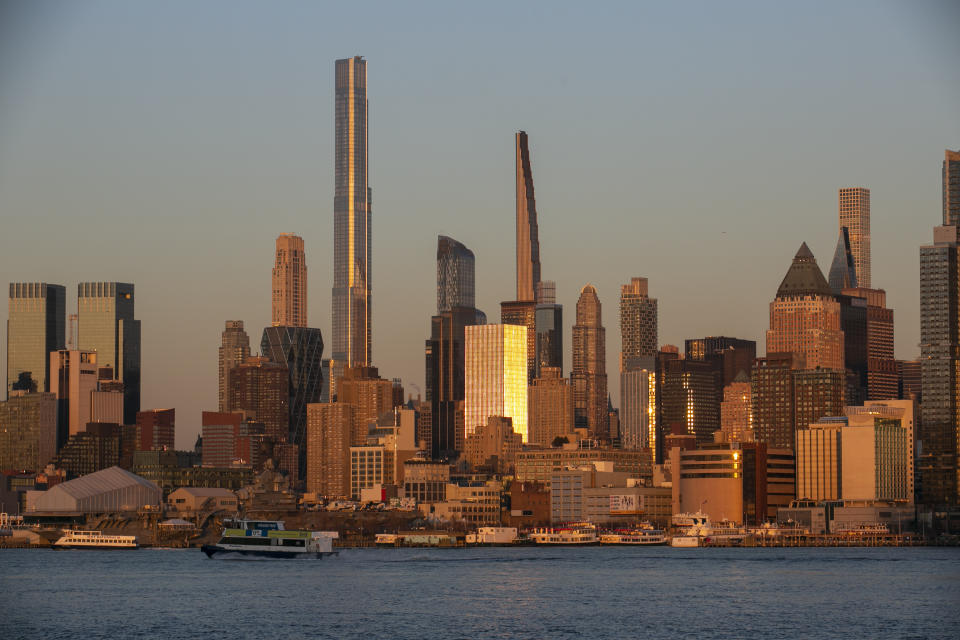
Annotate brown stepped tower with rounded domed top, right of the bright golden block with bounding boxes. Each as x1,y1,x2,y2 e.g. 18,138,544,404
570,284,610,438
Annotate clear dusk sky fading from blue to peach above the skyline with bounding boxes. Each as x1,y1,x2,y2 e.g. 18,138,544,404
0,0,960,448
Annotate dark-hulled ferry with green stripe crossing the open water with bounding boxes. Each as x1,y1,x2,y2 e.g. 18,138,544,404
201,520,338,558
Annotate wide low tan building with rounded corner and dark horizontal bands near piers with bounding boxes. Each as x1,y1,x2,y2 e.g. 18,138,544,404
670,442,796,524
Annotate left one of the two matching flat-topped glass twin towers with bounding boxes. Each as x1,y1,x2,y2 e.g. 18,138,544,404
6,282,67,395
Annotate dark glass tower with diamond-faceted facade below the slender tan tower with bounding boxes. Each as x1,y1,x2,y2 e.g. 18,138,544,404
260,327,323,478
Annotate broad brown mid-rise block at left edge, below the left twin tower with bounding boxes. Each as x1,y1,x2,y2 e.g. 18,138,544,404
0,391,57,471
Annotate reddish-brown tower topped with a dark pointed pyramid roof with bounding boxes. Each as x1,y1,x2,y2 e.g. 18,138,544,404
767,242,844,371
